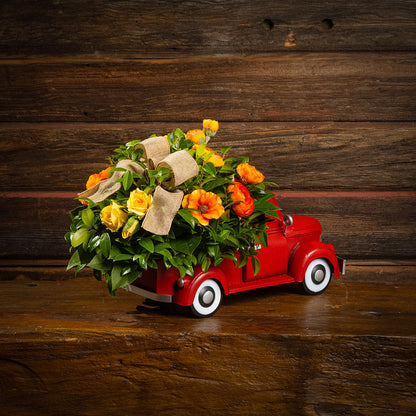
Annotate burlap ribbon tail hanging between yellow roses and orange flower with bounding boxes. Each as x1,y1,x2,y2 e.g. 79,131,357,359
142,186,183,235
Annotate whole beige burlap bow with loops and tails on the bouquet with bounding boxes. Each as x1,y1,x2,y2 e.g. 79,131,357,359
78,136,198,235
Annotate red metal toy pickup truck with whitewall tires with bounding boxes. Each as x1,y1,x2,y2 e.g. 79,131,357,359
126,200,345,318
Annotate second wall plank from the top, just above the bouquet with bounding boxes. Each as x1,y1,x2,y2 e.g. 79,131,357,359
0,52,416,122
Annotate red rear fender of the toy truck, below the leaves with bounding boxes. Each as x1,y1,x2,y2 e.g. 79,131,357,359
173,267,228,306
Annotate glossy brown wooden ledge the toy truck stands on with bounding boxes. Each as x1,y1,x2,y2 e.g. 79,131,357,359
0,279,416,415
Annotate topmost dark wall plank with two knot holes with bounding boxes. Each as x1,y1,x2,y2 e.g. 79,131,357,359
0,0,416,59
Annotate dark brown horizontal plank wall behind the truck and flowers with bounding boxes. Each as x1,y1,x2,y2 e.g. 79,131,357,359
0,0,416,278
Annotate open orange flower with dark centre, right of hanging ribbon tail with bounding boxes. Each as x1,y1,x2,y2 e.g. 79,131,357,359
182,189,224,225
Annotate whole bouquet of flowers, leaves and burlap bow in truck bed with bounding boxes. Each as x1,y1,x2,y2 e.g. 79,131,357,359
65,120,277,295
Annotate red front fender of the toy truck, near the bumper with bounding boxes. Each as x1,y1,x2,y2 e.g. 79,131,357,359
288,241,339,282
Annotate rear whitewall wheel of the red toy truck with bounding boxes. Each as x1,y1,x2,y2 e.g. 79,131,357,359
191,279,222,318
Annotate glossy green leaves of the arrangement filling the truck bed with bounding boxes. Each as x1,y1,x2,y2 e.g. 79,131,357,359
65,125,277,295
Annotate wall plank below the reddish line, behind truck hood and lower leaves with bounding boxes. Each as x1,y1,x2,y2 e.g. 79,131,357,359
0,194,416,259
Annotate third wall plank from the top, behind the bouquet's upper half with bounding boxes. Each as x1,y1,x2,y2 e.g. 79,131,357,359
0,122,416,192
